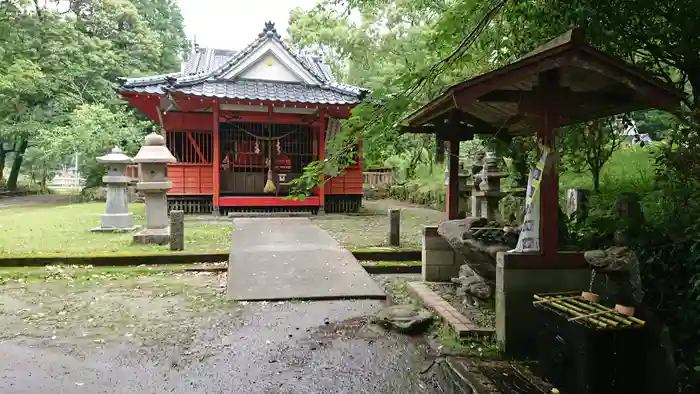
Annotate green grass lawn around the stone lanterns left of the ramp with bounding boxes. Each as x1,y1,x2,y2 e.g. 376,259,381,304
0,203,232,255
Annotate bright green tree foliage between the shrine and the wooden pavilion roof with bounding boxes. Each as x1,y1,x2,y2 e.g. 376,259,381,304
290,0,500,192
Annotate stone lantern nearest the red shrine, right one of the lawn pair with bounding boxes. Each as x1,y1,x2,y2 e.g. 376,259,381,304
134,133,176,245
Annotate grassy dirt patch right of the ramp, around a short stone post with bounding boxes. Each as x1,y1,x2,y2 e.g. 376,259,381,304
312,200,445,248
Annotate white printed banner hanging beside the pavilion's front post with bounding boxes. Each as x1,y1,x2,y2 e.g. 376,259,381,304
510,146,551,253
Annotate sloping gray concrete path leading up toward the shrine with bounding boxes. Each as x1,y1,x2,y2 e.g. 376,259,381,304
227,218,386,301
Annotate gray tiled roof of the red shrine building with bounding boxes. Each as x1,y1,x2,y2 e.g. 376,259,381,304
121,23,366,104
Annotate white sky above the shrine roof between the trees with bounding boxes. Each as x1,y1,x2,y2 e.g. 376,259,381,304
178,0,316,49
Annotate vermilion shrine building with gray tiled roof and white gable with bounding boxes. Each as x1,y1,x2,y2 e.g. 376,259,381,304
120,22,366,213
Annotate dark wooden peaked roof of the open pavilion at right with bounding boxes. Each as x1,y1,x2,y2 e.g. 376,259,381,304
402,28,684,135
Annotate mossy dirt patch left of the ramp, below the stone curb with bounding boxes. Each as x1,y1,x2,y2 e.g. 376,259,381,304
0,267,238,345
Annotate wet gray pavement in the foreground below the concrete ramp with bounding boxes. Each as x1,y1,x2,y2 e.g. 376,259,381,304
0,301,433,394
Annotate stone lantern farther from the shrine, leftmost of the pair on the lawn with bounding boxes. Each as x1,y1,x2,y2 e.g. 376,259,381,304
91,147,137,232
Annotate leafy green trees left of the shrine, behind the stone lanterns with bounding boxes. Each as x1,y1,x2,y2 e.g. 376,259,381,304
0,0,186,189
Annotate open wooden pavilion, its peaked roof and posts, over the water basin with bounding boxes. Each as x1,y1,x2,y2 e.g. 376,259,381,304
404,28,684,264
